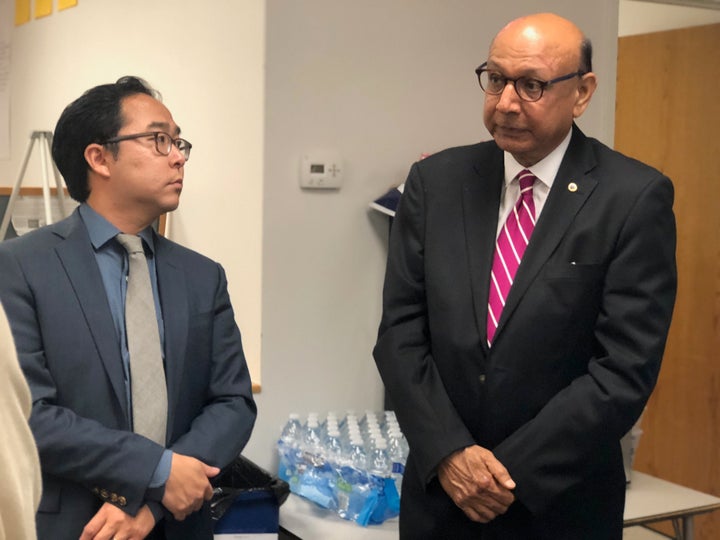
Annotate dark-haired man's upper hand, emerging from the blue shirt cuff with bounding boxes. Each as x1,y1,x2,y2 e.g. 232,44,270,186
162,453,220,521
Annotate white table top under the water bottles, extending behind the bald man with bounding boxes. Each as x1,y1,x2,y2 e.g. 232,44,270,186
280,471,720,540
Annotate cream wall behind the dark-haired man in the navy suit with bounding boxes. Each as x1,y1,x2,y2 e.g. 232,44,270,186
0,0,265,381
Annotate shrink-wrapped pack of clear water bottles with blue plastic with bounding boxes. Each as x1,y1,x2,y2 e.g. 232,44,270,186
277,411,408,527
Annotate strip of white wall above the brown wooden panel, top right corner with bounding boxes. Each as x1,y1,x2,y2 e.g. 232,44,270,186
618,0,720,36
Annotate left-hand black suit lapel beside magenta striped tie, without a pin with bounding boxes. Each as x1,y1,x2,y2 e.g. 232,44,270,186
463,146,504,349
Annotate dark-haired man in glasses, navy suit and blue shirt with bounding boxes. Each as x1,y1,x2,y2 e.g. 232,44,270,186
0,77,256,540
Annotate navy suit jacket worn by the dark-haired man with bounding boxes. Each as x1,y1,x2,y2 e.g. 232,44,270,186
0,212,256,540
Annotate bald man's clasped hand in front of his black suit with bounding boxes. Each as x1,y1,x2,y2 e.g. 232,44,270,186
438,446,515,523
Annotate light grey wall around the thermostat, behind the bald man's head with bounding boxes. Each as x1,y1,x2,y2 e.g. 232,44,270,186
246,0,617,469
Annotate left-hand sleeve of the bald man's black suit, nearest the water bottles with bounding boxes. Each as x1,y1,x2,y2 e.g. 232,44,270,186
373,164,474,482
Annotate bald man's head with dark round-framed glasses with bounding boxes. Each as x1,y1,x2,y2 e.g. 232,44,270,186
479,13,597,167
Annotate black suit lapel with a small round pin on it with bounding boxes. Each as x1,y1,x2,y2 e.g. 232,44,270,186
495,126,597,340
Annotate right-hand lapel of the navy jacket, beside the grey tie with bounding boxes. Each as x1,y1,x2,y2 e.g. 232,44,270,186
155,235,189,437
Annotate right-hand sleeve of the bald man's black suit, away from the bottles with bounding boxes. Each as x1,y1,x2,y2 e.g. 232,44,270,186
493,174,676,513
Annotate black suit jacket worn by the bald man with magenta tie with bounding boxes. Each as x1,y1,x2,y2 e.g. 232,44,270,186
374,127,676,540
